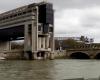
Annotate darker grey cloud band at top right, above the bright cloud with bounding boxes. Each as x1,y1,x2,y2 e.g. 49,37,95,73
48,0,100,8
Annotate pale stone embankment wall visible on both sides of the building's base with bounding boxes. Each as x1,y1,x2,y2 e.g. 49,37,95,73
0,50,67,60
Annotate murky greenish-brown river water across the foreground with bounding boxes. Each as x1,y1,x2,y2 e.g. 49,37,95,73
0,59,100,80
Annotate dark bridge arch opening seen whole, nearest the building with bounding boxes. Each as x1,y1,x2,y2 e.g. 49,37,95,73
69,52,90,59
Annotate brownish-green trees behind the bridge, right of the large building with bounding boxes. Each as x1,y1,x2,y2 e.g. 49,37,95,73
55,36,94,50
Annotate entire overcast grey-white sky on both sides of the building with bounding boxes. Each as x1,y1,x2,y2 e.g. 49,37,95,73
0,0,100,42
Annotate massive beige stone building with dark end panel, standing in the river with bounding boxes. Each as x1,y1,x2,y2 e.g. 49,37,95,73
0,2,54,59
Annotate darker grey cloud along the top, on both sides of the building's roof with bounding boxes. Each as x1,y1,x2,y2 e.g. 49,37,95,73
0,0,100,10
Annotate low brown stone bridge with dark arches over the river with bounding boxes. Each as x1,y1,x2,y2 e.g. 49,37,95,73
66,49,100,59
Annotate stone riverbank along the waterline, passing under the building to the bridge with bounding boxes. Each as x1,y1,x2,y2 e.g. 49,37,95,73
0,50,66,60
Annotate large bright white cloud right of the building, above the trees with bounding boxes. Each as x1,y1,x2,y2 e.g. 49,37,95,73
55,6,100,42
